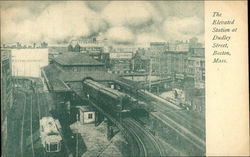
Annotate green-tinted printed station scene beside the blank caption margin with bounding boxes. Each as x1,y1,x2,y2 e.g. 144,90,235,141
0,1,206,157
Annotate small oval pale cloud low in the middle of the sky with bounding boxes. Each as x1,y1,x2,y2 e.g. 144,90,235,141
106,27,135,44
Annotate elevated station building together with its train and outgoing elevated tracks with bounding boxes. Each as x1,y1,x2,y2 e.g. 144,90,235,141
42,54,205,156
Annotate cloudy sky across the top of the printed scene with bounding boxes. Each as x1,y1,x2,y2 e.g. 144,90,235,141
1,1,204,44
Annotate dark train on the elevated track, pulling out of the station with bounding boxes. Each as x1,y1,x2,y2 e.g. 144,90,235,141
83,80,129,113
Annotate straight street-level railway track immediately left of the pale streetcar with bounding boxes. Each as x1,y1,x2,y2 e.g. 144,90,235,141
19,91,45,157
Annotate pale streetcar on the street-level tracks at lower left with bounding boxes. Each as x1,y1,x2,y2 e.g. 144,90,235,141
40,117,62,152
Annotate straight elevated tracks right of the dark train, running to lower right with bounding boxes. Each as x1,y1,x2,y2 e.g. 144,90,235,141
113,81,205,153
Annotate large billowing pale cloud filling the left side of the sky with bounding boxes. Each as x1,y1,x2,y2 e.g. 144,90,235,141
2,1,106,43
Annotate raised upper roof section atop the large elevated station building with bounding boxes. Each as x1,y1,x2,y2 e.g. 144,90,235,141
54,52,104,65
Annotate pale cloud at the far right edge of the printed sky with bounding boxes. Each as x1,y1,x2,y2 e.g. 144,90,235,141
162,16,204,40
